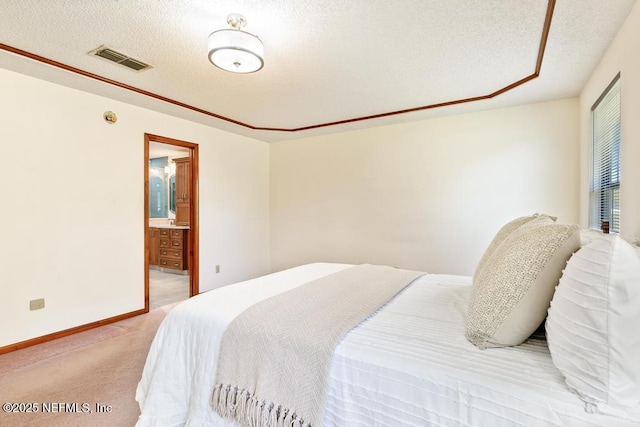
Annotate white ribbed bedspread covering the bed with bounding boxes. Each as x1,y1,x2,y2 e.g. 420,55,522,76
136,264,640,427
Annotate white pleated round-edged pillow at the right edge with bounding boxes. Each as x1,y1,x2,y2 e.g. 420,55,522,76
546,235,640,415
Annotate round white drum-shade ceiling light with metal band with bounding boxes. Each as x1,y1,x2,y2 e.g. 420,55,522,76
209,13,264,73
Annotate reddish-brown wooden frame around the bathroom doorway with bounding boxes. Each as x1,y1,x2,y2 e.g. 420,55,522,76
144,133,200,313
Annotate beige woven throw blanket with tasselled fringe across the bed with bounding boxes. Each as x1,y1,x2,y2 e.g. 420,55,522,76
212,265,424,427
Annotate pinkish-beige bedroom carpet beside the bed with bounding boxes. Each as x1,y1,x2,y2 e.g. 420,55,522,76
0,304,175,427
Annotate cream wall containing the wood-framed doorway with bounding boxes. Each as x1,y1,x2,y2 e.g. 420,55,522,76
0,69,269,347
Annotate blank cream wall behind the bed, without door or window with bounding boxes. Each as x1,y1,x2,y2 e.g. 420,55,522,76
270,98,579,275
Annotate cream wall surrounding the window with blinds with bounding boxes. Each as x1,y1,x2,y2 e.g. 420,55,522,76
580,3,640,240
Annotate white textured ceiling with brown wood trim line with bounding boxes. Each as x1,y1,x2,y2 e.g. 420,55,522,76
0,0,635,141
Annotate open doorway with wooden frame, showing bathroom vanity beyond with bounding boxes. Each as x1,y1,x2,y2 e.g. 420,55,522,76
144,134,199,311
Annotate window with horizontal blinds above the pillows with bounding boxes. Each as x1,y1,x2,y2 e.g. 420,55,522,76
589,73,620,233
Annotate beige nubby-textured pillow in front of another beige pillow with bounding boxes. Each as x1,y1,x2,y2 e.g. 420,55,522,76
465,216,580,348
